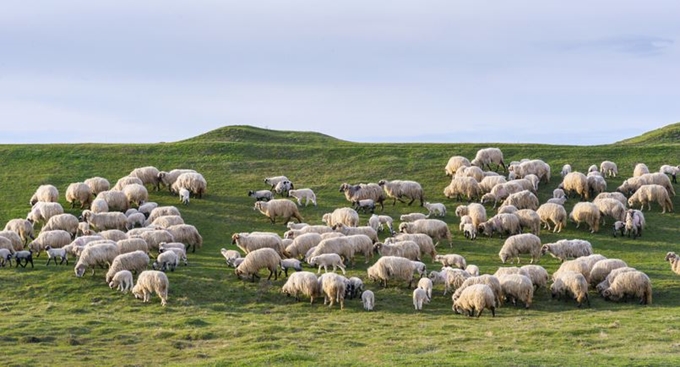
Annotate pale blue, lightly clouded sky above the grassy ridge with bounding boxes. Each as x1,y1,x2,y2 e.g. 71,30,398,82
0,0,680,145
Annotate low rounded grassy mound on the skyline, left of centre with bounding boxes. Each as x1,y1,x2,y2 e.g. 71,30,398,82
182,125,342,145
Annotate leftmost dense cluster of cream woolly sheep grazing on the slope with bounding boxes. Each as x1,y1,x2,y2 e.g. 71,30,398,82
0,166,207,306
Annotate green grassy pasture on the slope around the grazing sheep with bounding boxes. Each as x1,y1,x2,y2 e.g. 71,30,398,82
0,127,680,366
